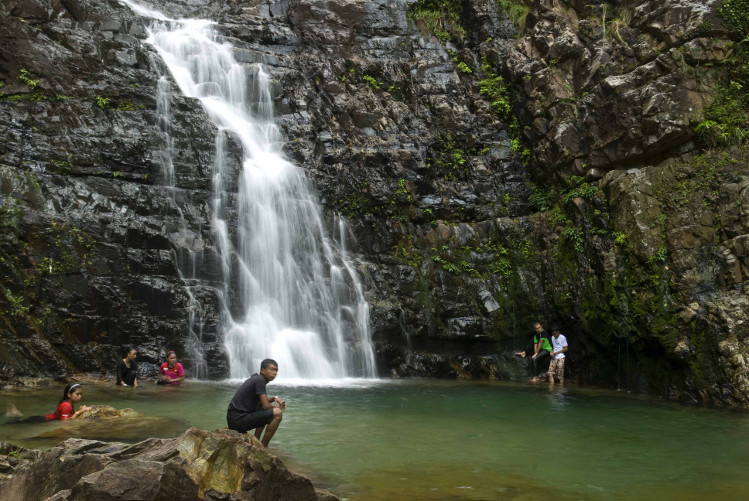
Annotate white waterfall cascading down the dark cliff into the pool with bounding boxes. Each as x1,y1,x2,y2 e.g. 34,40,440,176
121,0,375,379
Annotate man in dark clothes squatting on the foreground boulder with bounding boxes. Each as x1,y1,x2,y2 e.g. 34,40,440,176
226,358,286,447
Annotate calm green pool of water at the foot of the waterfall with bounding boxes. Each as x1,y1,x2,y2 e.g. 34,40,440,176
0,380,749,500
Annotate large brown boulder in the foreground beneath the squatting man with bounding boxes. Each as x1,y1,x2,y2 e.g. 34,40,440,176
0,428,337,501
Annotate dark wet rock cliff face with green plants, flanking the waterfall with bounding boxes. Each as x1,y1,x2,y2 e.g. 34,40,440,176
0,0,749,406
